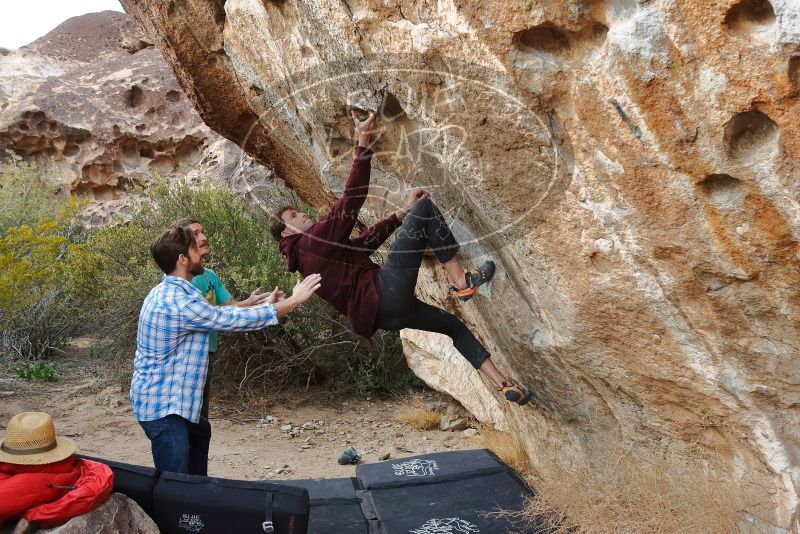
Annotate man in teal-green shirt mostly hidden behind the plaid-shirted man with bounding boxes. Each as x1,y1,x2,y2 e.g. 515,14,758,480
175,219,286,419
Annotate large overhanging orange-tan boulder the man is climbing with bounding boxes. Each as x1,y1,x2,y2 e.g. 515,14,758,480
122,0,800,531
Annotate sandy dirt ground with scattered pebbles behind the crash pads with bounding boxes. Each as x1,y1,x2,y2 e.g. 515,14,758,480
0,355,479,480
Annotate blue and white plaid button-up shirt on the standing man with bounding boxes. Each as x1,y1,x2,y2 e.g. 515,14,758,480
131,276,278,423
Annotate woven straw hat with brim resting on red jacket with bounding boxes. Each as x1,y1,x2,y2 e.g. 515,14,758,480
0,412,78,465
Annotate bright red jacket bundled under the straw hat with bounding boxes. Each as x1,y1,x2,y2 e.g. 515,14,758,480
0,456,114,528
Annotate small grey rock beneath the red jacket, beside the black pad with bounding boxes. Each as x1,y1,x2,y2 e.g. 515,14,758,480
38,493,159,534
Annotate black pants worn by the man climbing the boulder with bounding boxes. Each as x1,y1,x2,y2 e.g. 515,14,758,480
376,199,489,369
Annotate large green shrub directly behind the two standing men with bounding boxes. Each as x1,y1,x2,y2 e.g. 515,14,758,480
83,181,415,398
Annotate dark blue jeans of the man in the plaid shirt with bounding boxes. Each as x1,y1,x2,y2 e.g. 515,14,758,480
139,414,211,476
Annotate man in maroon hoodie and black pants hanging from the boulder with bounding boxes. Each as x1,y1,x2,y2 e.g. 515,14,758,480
270,111,531,405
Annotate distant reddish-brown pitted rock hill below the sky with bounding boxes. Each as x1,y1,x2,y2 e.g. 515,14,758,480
0,11,296,222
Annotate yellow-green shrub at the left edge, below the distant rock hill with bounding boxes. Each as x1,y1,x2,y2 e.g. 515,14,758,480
0,164,94,361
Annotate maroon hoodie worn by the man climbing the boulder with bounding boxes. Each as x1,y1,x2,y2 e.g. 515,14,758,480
280,147,400,337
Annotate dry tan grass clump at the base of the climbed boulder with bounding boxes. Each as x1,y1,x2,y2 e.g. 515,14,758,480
525,439,756,534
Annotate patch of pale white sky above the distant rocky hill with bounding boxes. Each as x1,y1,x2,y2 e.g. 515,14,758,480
0,0,123,48
